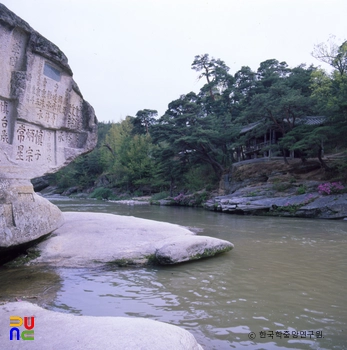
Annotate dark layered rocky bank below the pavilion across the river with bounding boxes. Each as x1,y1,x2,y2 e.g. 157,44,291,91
212,157,347,219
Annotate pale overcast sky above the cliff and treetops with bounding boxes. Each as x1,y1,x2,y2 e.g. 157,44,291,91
0,0,347,122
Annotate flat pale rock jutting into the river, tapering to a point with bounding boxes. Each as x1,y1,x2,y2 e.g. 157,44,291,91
25,212,233,267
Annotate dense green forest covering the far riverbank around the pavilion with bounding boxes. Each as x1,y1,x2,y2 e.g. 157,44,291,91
54,38,347,198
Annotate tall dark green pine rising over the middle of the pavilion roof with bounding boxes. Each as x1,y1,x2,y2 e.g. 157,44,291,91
241,60,313,163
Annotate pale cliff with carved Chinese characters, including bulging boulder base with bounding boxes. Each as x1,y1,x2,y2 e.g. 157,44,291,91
0,4,97,247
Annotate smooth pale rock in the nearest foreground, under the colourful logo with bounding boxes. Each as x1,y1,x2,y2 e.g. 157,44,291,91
0,302,202,350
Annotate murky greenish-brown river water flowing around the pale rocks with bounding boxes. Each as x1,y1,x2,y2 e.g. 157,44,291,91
0,200,347,350
